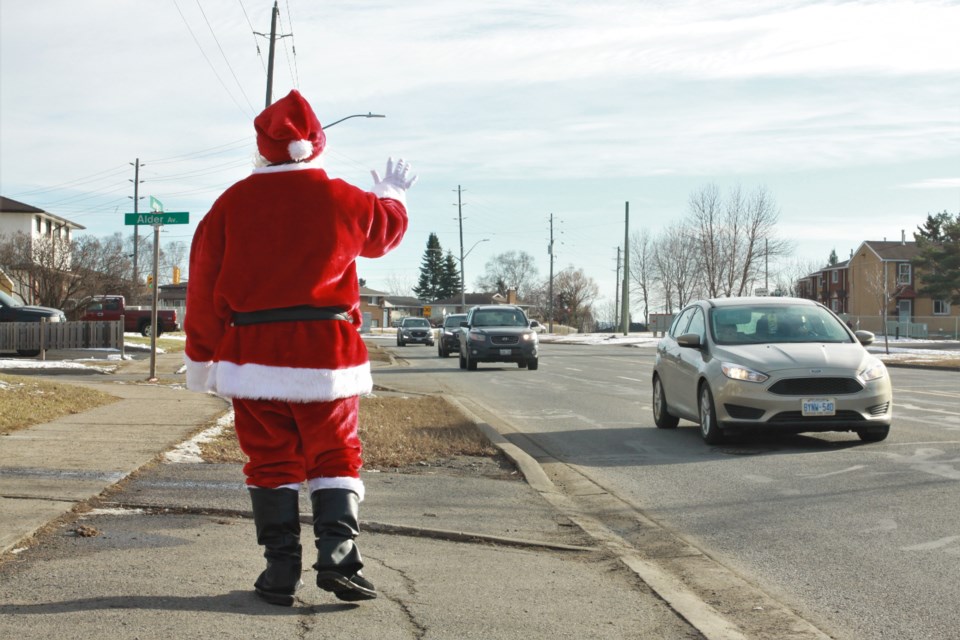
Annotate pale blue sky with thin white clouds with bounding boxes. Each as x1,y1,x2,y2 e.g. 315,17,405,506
0,0,960,316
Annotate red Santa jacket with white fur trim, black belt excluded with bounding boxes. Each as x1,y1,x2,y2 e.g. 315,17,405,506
184,164,407,402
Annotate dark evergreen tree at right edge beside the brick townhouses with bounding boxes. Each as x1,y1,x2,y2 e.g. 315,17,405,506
913,211,960,304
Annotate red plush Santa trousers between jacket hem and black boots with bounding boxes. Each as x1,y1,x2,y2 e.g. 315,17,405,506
233,396,363,489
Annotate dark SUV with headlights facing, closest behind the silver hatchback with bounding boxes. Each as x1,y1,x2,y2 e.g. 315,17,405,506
460,305,540,371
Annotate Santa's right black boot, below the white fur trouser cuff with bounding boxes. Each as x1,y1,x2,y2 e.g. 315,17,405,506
310,489,377,602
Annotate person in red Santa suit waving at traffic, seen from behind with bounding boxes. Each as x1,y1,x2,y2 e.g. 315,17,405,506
184,91,416,606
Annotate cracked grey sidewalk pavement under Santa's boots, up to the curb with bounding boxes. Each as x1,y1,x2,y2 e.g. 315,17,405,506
0,354,704,640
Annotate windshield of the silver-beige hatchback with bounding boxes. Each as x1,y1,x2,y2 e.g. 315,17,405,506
710,305,854,345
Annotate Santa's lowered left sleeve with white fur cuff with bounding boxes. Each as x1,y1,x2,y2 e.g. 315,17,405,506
183,215,224,391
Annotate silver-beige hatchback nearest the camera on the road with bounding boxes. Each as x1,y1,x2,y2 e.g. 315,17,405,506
652,298,893,444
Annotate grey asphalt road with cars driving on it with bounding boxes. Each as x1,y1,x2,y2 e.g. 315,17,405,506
379,344,960,640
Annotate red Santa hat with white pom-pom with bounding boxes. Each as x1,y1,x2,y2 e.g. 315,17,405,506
253,89,327,164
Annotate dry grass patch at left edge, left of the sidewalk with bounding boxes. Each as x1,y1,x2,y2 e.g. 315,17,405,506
0,375,119,433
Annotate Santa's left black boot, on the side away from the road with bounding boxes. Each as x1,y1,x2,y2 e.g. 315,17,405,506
250,489,303,607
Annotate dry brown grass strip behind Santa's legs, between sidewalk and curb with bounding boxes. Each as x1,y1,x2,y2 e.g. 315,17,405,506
200,396,497,469
